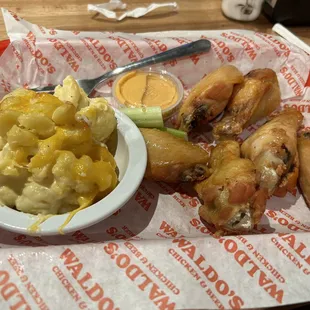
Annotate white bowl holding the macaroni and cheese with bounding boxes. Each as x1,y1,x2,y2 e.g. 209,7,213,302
0,110,147,236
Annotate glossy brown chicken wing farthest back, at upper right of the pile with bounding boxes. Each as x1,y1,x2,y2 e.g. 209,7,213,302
213,69,281,139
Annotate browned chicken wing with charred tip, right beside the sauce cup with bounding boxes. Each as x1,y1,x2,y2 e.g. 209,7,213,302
178,65,244,132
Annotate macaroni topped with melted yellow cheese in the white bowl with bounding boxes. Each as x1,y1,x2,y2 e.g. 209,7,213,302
0,76,117,233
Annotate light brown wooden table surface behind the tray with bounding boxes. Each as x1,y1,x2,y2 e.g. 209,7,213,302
0,0,310,44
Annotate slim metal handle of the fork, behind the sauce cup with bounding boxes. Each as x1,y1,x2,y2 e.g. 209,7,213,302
92,39,211,86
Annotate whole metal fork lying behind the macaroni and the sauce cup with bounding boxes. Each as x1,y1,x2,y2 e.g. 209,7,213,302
32,39,211,95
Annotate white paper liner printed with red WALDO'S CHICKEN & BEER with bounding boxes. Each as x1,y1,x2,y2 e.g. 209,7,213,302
0,10,310,310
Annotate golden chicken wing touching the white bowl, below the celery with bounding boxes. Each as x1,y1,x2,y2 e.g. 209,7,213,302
140,128,209,183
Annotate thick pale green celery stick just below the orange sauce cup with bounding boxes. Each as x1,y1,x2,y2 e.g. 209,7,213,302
120,107,164,128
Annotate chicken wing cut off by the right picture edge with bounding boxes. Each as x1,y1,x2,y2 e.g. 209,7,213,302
297,131,310,208
